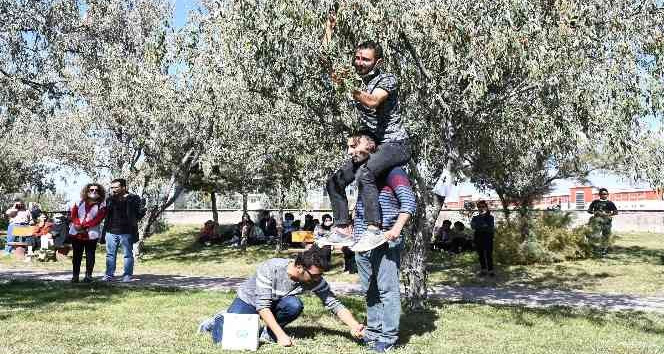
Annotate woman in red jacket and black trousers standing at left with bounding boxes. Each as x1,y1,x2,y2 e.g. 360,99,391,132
69,183,106,283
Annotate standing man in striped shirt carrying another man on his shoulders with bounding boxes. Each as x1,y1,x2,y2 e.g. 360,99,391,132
348,132,416,353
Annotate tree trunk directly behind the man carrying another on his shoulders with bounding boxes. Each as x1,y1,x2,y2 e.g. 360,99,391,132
402,162,444,310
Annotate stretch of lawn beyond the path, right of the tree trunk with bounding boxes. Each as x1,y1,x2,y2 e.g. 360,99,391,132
429,233,664,296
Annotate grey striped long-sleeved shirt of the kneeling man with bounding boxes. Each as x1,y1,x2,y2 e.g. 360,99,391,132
237,258,345,314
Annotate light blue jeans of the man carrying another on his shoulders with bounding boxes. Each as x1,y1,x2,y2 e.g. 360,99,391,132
355,238,403,344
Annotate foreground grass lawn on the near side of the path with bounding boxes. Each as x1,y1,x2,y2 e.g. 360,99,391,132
0,281,664,354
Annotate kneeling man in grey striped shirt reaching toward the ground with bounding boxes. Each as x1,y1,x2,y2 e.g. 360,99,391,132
199,246,364,347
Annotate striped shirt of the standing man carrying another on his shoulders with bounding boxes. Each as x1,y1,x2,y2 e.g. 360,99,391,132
353,167,417,241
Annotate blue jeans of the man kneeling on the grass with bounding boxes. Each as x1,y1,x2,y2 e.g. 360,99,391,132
211,296,304,343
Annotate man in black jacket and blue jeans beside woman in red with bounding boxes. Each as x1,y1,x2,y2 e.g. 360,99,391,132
102,178,145,282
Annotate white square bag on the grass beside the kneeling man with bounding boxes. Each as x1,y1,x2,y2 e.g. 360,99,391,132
221,313,259,351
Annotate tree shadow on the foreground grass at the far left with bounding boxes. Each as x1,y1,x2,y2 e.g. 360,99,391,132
0,280,191,320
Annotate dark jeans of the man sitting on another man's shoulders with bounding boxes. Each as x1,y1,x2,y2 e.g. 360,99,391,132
327,140,410,226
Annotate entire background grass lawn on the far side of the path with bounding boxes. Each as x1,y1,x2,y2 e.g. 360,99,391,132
0,226,664,296
